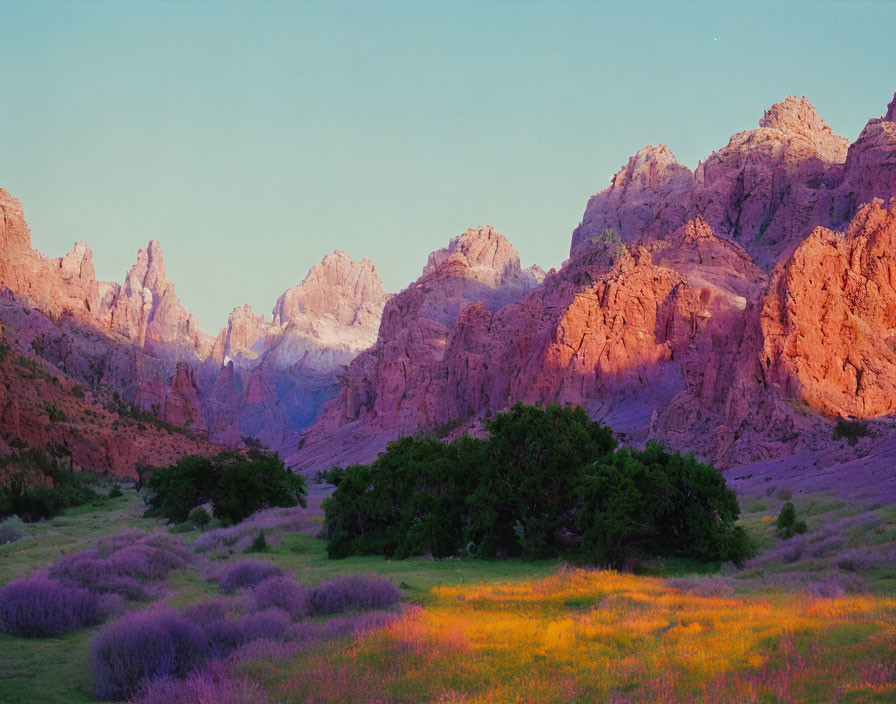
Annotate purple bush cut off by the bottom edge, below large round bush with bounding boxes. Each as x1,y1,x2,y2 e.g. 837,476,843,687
134,663,268,704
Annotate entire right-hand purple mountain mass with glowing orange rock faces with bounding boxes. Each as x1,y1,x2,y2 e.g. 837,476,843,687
288,89,896,470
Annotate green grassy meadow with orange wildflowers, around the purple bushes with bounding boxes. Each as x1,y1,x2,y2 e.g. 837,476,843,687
0,492,896,704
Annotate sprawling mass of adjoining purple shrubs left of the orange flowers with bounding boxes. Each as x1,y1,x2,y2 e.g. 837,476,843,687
90,568,399,704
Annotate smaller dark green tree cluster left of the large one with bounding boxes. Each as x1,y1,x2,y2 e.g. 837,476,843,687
146,450,308,524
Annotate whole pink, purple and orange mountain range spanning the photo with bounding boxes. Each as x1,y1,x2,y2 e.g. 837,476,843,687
0,96,896,478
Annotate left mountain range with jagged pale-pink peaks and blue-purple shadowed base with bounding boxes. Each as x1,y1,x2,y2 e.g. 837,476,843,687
0,189,387,462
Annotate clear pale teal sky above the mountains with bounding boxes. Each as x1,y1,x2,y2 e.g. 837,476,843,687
0,0,896,333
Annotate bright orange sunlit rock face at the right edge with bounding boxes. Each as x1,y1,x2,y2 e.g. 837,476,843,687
762,199,896,418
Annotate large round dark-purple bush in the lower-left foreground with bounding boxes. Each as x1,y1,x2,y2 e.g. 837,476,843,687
90,611,208,700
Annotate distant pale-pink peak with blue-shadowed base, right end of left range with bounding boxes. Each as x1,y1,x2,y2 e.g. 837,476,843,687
200,251,388,449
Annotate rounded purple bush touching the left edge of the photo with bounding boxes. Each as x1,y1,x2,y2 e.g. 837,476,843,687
0,578,104,637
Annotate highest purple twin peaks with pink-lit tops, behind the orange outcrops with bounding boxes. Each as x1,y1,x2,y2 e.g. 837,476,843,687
572,96,848,270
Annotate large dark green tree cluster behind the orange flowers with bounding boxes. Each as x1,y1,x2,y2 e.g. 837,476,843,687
322,404,751,567
